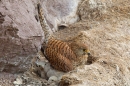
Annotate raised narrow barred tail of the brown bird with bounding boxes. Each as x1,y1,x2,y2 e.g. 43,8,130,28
37,3,52,42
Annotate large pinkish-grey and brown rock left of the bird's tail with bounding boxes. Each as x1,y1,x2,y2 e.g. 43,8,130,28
0,0,44,72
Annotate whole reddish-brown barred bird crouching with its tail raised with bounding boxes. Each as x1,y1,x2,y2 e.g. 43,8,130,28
38,4,89,72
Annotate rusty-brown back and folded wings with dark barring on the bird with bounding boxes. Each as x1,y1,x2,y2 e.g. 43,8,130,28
44,38,77,72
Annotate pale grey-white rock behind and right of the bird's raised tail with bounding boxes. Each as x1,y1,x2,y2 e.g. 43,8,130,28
41,0,80,32
